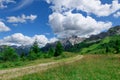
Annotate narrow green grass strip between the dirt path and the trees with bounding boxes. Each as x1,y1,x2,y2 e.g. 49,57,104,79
0,52,76,70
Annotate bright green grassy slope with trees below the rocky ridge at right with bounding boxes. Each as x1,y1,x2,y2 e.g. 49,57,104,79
80,35,120,54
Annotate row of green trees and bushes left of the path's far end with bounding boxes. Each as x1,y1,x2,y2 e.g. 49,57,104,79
0,41,64,62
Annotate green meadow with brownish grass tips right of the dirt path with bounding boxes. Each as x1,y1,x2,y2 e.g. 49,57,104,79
13,54,120,80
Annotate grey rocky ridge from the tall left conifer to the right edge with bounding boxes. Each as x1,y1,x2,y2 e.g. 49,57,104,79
42,26,120,51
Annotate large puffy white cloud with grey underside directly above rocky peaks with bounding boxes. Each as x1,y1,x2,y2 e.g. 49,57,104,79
49,12,112,37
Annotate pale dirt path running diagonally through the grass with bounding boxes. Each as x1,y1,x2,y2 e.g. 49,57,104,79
0,55,83,80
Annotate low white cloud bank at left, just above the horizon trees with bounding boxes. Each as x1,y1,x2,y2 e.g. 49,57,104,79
0,33,56,47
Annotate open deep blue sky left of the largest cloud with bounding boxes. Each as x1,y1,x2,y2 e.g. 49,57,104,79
0,0,54,38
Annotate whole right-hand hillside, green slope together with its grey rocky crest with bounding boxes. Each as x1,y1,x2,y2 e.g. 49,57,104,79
69,26,120,54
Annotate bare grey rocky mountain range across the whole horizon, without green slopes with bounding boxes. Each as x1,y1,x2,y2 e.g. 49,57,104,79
0,26,120,54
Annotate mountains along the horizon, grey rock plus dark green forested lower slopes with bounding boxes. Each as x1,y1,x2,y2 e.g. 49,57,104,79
0,26,120,54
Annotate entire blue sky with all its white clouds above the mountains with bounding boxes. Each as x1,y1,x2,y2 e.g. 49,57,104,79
0,0,120,47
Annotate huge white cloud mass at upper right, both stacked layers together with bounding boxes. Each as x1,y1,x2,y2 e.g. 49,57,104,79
46,0,115,38
